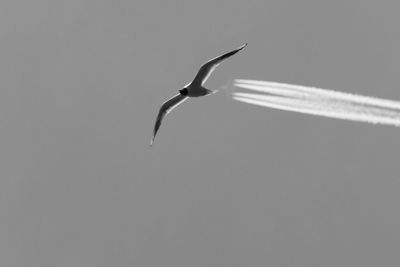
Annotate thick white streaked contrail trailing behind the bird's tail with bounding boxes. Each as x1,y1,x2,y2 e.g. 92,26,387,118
233,80,400,126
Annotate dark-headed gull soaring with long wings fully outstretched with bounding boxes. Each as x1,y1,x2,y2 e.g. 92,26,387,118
150,43,247,146
